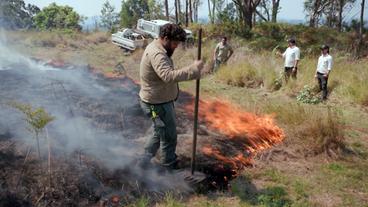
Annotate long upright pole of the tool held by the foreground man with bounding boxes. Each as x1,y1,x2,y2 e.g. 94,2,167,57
190,28,202,175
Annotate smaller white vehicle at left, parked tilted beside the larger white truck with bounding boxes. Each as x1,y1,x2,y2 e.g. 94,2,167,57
111,29,147,51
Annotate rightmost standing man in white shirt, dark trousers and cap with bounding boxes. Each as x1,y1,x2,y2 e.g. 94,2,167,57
315,45,332,100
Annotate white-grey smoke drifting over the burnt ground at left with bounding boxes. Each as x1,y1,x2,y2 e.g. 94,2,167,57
0,29,188,190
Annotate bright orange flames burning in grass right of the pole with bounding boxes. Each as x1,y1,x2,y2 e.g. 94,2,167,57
186,100,285,169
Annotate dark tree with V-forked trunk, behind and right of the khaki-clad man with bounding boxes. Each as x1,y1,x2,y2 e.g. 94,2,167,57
233,0,261,30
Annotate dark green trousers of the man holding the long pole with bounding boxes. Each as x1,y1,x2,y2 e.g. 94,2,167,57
141,101,177,167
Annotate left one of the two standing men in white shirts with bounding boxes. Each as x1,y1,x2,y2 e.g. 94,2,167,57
282,39,300,82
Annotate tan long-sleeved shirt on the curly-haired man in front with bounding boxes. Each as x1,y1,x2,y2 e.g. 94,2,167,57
139,40,200,104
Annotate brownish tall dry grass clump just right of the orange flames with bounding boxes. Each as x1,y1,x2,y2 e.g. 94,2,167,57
263,102,345,156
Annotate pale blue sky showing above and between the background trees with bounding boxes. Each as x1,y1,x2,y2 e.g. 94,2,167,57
25,0,368,20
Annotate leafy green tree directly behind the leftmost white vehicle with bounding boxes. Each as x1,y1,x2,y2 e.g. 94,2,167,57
120,0,149,27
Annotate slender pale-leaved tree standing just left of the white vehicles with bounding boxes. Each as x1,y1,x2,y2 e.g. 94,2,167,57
101,0,119,31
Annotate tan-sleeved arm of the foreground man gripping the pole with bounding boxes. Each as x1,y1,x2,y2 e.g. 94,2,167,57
151,53,203,83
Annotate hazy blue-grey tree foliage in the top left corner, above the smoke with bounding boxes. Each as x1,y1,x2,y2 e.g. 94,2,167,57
0,0,40,29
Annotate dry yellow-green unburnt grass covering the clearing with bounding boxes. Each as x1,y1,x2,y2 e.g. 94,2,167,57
5,29,368,206
